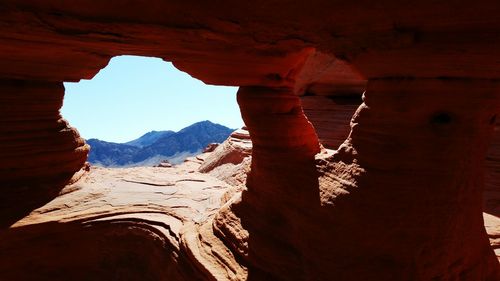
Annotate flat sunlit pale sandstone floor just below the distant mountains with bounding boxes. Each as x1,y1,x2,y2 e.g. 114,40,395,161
11,163,231,228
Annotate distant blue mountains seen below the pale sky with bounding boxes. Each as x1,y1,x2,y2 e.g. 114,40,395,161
87,121,234,167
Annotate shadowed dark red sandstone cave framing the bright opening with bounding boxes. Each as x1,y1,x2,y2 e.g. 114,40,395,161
0,1,500,281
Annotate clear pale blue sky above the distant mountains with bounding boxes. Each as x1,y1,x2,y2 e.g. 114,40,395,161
61,56,243,142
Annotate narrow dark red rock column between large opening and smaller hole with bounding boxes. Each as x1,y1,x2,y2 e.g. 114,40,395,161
214,87,319,280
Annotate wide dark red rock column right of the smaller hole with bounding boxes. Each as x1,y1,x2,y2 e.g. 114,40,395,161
314,79,500,281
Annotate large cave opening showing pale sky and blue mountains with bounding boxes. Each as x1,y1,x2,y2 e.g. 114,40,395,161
61,56,243,167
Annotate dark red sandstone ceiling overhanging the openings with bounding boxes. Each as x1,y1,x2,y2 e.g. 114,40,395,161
0,0,500,82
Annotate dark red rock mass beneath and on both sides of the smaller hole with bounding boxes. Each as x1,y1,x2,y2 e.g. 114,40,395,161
214,79,500,281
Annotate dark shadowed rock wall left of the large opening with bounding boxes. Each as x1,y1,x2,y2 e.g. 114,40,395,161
0,80,88,227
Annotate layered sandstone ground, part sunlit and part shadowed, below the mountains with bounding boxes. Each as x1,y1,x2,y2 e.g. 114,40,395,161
0,126,500,280
